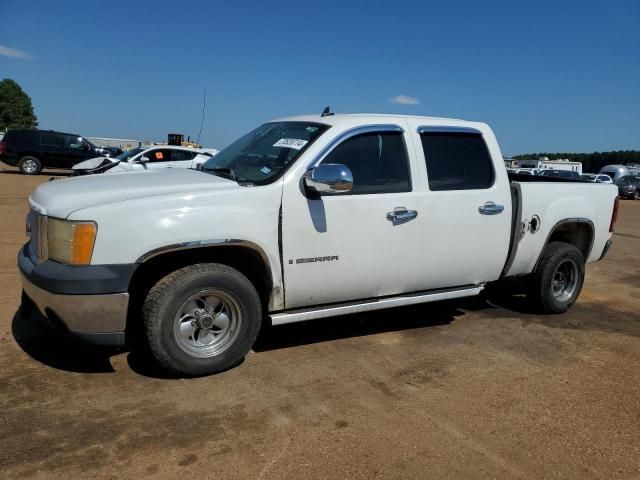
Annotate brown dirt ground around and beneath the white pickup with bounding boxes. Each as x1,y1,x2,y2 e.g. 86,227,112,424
0,168,640,479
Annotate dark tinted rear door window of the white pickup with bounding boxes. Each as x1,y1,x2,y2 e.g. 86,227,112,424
420,132,495,191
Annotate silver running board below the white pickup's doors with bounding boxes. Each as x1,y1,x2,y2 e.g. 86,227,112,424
269,285,484,325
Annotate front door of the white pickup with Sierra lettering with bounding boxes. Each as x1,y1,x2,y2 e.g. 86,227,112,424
282,127,422,308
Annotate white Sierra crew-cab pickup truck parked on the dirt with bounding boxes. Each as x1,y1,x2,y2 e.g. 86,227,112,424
19,115,617,375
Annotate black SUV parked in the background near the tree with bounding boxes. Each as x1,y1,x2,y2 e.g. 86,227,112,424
0,130,104,175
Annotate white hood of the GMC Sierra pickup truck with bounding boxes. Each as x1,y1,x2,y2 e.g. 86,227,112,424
29,168,241,218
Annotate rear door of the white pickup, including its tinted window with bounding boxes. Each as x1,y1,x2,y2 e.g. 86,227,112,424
410,120,512,289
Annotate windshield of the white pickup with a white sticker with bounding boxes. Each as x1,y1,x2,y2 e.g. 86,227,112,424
202,122,329,185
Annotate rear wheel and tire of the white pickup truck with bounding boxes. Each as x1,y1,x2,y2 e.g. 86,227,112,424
527,242,584,313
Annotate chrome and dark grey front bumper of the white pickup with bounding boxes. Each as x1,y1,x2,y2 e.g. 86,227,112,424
18,247,136,346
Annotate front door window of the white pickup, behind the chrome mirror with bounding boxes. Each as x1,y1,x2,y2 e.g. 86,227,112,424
322,132,411,195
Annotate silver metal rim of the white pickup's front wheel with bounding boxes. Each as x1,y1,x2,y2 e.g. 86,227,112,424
173,289,242,358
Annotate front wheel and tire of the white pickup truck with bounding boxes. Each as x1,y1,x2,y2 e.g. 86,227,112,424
143,263,262,376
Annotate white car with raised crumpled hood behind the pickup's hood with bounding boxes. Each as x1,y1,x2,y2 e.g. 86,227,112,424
72,145,218,176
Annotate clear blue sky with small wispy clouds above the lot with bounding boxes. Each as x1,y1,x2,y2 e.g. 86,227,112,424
0,0,640,155
